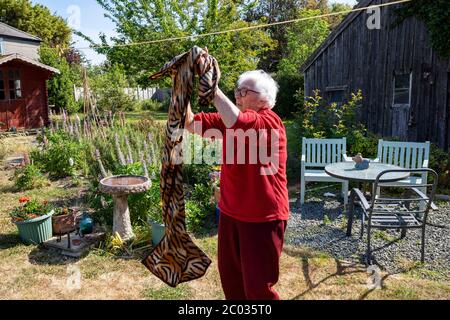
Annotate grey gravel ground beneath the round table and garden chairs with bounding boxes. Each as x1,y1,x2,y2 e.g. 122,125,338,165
286,189,450,281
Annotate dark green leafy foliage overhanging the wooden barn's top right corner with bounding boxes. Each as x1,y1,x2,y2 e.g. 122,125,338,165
397,0,450,58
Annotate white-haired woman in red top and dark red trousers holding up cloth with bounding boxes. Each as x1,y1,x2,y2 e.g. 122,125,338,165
186,70,289,300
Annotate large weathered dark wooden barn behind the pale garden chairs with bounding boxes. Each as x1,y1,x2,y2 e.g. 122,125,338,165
301,0,450,149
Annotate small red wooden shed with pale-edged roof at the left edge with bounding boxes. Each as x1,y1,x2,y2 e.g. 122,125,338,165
0,53,60,130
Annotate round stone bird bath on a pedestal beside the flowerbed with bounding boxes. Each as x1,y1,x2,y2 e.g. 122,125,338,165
99,176,151,240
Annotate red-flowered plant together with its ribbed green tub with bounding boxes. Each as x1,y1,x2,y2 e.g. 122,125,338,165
10,197,54,244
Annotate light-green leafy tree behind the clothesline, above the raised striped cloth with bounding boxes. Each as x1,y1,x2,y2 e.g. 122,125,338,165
79,0,275,100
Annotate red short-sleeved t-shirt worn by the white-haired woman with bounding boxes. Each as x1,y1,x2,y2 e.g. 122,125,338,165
194,109,289,222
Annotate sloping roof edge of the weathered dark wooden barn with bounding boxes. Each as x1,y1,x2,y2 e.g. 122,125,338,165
300,0,374,73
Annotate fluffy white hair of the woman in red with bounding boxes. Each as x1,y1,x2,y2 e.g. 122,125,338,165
237,70,279,109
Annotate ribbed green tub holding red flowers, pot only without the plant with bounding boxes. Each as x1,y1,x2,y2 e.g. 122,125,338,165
14,210,53,244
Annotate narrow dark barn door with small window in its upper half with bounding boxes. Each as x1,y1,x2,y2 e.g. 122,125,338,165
391,73,412,140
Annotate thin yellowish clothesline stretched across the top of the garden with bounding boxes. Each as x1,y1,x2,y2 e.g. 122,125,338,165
75,0,412,50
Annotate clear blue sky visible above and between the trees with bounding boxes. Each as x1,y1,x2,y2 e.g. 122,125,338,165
32,0,356,64
